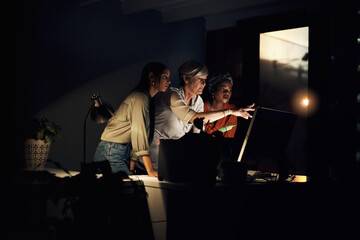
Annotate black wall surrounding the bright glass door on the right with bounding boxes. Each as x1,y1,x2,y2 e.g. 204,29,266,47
206,4,360,180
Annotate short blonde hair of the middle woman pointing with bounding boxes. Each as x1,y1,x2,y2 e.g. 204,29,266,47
178,60,209,86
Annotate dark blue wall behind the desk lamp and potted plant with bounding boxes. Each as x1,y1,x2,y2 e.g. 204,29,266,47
11,0,205,169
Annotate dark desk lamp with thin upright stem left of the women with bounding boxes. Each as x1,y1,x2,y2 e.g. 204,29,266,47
82,93,114,168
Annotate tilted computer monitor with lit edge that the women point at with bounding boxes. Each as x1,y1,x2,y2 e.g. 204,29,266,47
237,107,297,176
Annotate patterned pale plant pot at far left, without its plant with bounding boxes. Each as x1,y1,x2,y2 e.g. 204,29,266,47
24,139,51,170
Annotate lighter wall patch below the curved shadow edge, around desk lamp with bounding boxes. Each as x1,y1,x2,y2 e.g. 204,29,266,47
37,61,153,170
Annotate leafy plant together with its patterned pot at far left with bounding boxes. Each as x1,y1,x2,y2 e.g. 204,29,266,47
24,117,61,169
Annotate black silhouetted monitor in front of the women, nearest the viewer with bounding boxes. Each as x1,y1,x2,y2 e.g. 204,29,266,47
158,133,220,185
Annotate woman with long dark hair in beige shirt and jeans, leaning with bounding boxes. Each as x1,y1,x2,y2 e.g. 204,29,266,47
94,62,170,177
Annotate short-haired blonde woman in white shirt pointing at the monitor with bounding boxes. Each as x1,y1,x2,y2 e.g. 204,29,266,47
150,60,254,172
